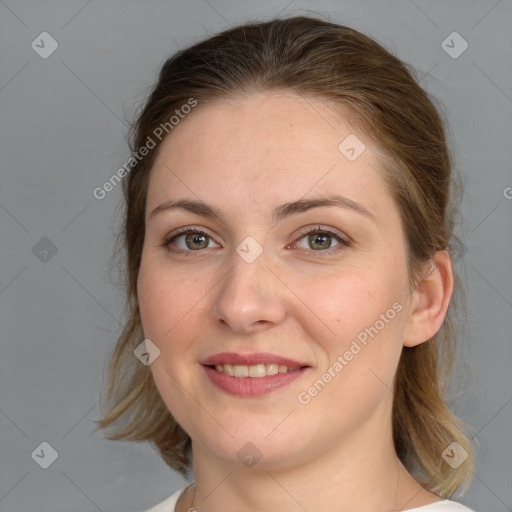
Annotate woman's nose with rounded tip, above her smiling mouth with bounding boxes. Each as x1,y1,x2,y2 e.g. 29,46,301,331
212,242,288,334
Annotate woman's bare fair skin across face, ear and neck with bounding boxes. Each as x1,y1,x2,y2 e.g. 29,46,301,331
138,91,453,512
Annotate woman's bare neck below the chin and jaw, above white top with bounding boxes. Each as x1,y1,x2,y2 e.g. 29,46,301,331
176,412,439,512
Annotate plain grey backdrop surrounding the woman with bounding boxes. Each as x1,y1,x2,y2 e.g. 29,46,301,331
0,0,512,512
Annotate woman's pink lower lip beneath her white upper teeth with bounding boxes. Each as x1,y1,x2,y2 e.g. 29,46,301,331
203,365,308,396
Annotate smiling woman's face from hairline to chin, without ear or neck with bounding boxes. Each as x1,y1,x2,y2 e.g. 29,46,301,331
138,92,410,468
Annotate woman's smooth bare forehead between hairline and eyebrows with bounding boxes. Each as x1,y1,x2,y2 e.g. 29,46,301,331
148,91,390,222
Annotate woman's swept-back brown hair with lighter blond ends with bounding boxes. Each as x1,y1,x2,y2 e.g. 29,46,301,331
96,16,474,497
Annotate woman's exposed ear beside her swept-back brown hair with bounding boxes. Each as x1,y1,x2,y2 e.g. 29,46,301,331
404,251,453,347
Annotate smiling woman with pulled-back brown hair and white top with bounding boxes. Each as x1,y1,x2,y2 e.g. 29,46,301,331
98,17,473,512
